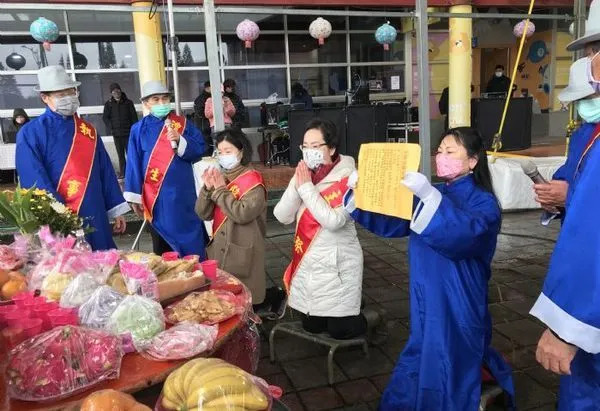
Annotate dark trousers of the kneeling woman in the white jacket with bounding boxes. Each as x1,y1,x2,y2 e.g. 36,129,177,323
301,313,367,340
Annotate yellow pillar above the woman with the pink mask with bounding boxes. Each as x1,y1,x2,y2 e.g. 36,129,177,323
448,4,473,128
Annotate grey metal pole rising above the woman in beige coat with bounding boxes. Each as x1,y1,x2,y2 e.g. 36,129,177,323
203,0,225,131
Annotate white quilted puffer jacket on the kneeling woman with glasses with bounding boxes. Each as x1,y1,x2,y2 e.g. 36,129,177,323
274,156,363,317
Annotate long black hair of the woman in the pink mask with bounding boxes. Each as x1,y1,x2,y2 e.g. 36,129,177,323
440,127,497,199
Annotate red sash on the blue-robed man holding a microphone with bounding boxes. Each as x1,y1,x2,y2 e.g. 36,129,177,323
142,113,186,221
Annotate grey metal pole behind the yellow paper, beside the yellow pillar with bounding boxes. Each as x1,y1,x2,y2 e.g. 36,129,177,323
416,0,431,179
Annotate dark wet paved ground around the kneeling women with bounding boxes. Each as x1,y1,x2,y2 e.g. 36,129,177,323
119,212,559,411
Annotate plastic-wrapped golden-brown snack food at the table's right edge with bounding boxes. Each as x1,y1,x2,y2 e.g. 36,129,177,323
165,290,238,324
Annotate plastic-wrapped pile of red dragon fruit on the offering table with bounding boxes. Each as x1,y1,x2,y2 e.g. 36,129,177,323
6,326,123,401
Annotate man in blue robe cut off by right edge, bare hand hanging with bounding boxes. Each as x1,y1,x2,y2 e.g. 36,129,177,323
530,0,600,411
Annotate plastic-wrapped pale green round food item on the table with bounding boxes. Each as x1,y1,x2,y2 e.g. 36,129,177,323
106,295,165,351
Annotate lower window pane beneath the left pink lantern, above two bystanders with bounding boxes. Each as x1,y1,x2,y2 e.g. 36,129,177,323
225,68,287,100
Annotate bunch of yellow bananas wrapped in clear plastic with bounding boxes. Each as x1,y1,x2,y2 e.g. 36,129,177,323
161,358,269,411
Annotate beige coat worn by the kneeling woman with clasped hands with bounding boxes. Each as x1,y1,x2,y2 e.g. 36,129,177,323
196,166,267,304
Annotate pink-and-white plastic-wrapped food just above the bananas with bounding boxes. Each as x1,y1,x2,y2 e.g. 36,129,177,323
144,322,219,361
